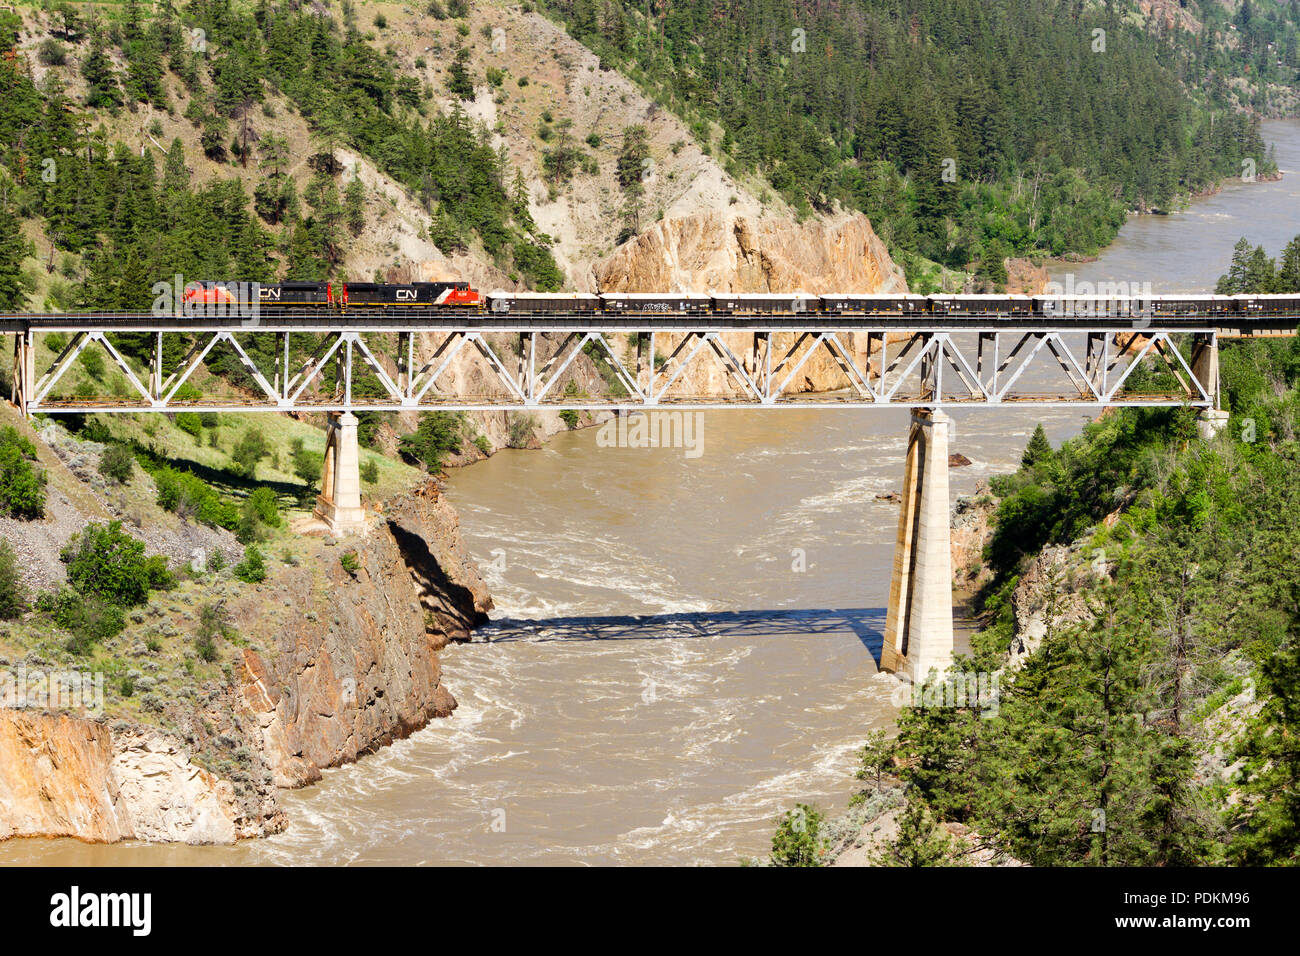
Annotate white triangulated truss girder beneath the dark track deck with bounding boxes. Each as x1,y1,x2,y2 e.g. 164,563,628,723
14,323,1218,414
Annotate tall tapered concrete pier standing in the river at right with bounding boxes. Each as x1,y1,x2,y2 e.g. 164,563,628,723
880,408,953,683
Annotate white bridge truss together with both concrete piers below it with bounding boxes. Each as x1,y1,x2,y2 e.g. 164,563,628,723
7,316,1240,682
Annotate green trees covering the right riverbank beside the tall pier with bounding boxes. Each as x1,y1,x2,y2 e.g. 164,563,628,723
774,237,1300,866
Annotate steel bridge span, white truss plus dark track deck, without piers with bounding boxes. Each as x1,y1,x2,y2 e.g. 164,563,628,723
0,311,1279,414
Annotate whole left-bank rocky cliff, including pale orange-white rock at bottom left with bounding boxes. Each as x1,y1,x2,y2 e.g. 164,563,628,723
0,479,491,844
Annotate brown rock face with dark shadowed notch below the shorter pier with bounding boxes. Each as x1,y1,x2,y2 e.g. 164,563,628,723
239,480,491,787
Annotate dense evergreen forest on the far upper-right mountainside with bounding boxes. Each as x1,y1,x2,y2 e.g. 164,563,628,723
545,0,1279,283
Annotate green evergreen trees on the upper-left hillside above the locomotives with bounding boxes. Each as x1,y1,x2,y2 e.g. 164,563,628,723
0,0,563,308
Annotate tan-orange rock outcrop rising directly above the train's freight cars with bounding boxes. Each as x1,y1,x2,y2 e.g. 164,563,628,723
594,212,907,294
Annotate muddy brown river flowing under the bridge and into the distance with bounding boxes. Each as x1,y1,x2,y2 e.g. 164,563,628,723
10,122,1300,865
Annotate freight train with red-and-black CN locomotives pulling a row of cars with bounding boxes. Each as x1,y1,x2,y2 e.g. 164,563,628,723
185,281,1300,319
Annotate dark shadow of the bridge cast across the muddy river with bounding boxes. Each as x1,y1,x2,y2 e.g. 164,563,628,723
475,607,885,666
